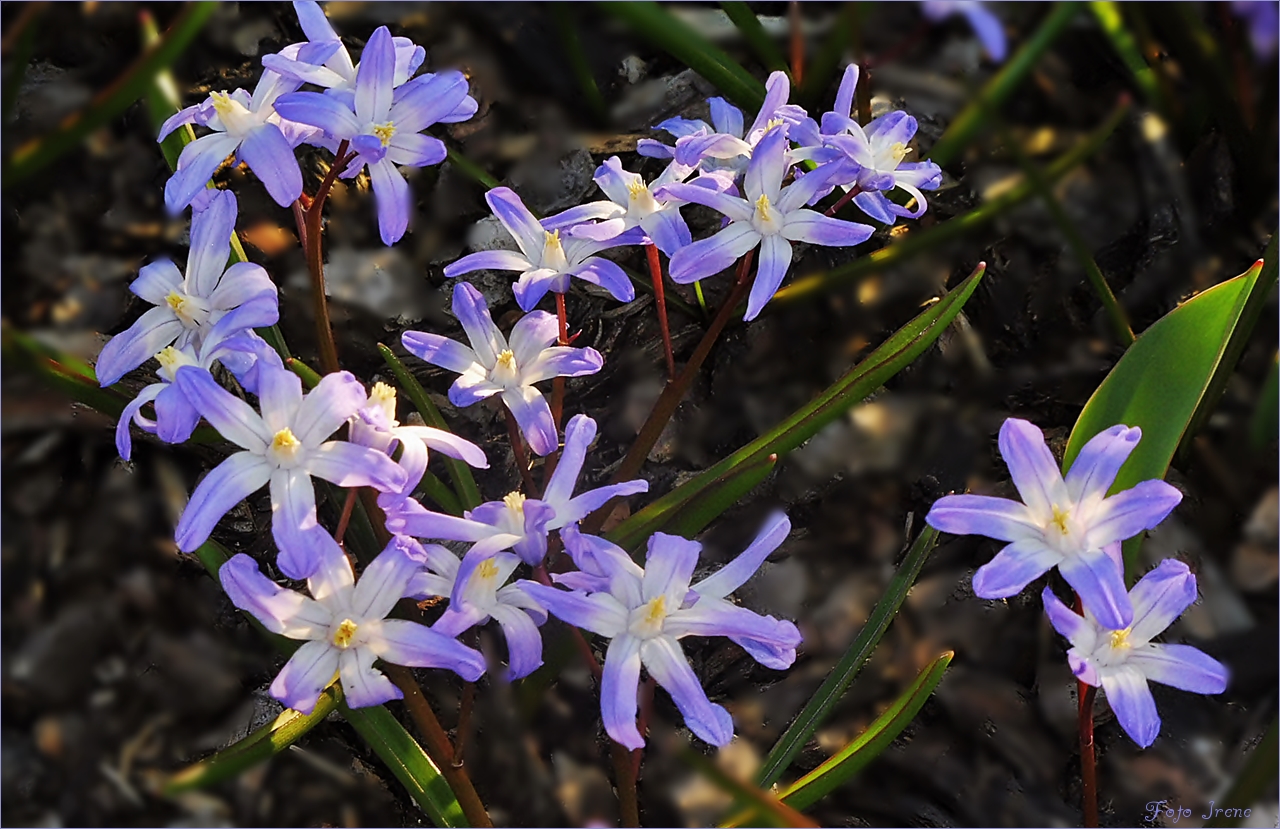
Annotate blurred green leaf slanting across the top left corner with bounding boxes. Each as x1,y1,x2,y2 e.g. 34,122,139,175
3,3,218,187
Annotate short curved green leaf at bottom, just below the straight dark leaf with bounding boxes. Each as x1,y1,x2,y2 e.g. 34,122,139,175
782,651,955,809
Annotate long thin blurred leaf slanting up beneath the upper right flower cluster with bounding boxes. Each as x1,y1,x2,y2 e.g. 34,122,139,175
764,101,1129,307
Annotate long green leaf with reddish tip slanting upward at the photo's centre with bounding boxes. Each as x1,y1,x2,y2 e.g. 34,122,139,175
608,265,986,539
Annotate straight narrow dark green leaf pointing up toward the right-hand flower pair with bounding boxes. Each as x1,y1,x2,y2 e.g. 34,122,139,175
756,527,938,788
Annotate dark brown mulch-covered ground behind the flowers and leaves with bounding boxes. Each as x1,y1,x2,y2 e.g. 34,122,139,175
0,3,1277,826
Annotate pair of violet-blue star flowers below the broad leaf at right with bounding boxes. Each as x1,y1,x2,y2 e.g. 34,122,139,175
927,418,1226,747
